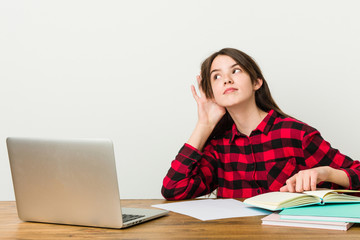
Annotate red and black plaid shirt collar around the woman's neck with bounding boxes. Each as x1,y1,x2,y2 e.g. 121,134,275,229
230,109,278,142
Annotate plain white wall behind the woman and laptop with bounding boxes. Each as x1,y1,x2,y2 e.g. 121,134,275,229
0,0,360,200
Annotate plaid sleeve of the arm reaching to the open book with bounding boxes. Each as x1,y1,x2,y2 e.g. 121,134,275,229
303,129,360,189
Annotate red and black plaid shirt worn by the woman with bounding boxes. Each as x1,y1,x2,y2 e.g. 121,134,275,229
162,110,360,200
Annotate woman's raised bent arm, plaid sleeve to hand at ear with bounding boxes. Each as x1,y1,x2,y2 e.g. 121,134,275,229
161,76,226,200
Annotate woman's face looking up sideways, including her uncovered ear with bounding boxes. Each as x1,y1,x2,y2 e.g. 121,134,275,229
210,55,262,107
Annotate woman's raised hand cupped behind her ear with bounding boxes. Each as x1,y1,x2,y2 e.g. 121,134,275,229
191,75,226,127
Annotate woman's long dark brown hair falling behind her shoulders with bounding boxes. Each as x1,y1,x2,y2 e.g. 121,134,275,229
200,48,289,140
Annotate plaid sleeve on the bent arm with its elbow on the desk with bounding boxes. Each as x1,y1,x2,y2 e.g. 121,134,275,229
161,144,217,200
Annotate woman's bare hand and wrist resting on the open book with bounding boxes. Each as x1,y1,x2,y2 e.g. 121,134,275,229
280,166,350,192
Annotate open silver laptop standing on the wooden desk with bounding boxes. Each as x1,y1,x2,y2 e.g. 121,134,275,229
6,137,168,228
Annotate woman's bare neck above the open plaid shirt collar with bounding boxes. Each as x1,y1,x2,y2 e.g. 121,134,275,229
227,104,267,136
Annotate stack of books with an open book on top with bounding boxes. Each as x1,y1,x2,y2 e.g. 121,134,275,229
244,189,360,231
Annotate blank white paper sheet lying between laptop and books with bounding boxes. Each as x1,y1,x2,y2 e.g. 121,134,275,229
152,199,271,221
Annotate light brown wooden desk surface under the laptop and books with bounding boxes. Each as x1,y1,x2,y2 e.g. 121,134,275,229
0,200,360,240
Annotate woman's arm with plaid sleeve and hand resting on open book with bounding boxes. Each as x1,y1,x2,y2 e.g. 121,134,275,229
280,129,360,192
